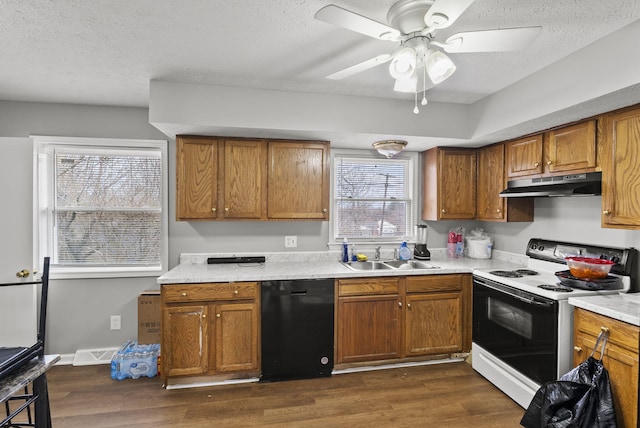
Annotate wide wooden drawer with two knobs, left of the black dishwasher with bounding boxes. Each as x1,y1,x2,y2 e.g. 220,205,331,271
162,282,259,303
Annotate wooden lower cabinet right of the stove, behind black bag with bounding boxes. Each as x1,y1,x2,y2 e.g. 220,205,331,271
573,308,640,428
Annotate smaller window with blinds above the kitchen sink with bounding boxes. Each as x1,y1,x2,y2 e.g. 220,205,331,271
333,154,415,242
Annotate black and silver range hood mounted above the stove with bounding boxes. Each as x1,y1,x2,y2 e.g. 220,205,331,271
500,172,602,198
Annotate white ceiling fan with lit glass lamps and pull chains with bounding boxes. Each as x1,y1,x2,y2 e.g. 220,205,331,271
315,0,541,114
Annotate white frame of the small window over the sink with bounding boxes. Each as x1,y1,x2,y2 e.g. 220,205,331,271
327,149,420,249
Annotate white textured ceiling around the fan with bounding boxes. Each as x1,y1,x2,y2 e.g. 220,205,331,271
0,0,640,107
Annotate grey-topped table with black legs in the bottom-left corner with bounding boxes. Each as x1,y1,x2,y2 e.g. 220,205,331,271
0,355,60,428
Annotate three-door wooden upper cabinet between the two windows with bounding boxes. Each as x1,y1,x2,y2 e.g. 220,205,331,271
176,136,330,220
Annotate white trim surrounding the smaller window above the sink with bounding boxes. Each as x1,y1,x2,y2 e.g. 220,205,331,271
327,149,421,250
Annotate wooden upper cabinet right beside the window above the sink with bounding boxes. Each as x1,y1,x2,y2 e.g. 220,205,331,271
422,147,476,220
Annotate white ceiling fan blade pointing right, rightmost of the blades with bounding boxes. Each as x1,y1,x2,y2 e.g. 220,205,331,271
440,27,542,53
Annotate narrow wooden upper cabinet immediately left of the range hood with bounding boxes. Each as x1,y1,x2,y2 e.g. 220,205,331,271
477,143,533,222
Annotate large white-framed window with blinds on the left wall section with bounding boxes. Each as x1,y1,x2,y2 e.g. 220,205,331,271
34,137,167,278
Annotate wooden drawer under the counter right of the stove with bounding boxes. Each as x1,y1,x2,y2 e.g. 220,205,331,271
574,308,640,353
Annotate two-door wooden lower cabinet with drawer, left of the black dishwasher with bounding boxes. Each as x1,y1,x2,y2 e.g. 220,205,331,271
161,282,260,385
